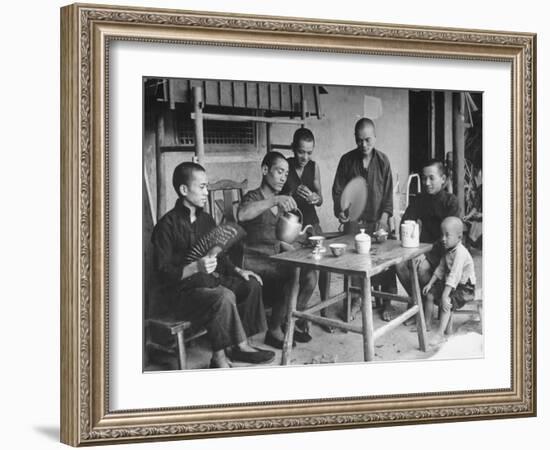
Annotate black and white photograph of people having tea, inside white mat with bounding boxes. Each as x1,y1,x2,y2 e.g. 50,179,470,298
141,76,484,372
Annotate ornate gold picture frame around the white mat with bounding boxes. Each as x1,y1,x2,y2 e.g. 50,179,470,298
61,4,536,446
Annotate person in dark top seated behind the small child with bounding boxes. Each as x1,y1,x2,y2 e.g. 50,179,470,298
397,159,460,300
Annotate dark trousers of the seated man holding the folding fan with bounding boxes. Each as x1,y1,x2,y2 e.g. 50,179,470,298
171,276,267,351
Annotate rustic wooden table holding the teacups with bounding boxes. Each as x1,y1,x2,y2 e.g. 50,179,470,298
272,236,432,365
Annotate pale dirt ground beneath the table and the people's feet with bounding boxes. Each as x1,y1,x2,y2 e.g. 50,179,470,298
145,249,483,371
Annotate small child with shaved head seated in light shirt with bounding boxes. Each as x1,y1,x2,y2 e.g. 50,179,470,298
422,217,476,345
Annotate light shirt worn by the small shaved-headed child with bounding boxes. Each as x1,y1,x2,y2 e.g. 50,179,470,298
434,242,476,289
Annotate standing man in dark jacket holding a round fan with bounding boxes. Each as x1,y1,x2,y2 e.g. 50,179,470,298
332,117,397,321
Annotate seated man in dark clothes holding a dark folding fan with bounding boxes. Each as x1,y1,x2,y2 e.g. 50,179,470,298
151,162,275,368
